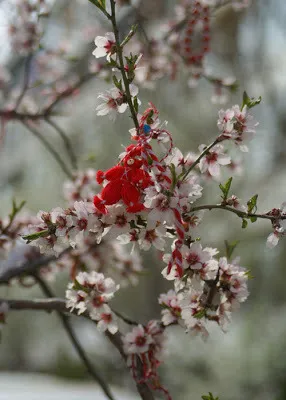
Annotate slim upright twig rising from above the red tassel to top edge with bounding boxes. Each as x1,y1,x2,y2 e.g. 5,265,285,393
110,0,139,130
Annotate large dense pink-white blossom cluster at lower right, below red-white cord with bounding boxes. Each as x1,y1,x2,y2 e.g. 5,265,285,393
159,248,248,337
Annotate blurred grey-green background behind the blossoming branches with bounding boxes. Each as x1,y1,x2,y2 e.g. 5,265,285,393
0,0,286,400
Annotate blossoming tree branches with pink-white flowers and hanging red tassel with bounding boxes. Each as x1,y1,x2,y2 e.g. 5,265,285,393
0,0,286,400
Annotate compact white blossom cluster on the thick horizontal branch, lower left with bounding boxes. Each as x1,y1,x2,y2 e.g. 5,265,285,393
66,271,119,334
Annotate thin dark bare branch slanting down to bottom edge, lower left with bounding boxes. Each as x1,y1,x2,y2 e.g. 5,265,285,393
34,274,115,400
